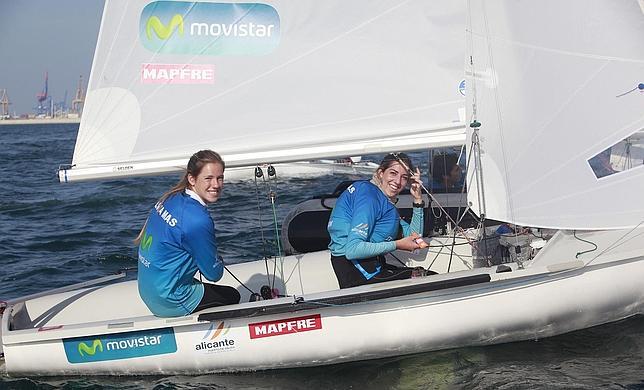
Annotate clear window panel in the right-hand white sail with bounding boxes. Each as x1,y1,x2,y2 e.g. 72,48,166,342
588,129,644,179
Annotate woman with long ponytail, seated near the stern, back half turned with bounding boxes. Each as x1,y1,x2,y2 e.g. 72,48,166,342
137,150,240,317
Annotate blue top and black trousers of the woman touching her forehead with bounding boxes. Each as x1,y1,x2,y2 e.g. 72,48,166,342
327,181,423,288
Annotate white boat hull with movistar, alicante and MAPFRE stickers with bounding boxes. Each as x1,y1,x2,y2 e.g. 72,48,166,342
2,229,644,375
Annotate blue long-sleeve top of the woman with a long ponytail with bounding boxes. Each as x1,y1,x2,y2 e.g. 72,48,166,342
138,191,223,317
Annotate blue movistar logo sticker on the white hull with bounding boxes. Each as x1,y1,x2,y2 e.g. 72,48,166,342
63,328,177,363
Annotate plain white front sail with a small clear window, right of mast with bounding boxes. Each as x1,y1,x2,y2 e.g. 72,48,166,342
466,0,644,229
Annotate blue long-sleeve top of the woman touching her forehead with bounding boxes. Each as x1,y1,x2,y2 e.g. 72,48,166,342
327,181,423,260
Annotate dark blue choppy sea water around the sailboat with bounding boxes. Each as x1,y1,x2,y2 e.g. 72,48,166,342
0,125,644,389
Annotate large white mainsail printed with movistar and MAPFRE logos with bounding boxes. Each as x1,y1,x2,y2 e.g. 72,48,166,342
60,0,465,181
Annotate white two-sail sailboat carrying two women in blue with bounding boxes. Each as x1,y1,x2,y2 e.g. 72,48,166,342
1,0,644,375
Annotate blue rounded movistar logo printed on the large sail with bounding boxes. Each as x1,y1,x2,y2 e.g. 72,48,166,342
139,1,280,56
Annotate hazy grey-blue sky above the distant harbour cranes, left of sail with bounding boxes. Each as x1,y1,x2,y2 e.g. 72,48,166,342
0,0,104,115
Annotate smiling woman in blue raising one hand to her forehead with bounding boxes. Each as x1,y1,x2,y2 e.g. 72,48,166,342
327,153,427,288
